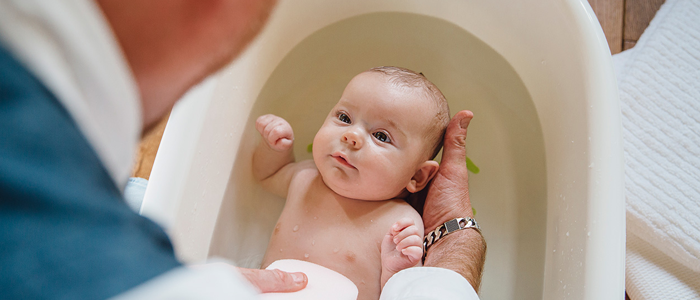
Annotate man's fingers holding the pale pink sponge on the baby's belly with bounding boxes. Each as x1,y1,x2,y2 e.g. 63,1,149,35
238,268,309,293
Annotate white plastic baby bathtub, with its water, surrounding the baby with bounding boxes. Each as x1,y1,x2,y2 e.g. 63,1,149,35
142,0,625,299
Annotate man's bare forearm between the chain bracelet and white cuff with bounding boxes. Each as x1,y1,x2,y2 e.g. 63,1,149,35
424,229,486,292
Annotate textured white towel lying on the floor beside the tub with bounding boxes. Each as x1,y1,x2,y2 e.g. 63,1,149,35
613,0,700,300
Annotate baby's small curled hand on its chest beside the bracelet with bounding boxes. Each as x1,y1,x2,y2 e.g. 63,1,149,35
382,217,423,279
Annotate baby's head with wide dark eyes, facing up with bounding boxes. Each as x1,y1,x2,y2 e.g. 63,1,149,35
313,67,450,200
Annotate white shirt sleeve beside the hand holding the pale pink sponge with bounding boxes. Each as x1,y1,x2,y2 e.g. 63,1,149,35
111,262,259,300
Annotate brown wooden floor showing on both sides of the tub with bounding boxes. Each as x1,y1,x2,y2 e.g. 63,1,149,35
132,0,665,299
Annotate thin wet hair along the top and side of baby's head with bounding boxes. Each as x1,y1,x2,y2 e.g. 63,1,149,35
367,66,450,159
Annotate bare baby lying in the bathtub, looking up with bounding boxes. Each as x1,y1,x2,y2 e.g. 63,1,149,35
253,67,450,299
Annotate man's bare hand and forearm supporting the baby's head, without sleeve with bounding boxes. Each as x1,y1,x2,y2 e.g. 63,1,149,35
416,110,486,292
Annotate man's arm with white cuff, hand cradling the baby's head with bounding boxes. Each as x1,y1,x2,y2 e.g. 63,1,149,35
380,111,486,300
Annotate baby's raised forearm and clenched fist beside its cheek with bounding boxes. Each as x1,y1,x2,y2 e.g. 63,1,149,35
253,115,294,197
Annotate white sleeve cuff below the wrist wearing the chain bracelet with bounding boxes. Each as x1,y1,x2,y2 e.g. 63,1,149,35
379,267,479,300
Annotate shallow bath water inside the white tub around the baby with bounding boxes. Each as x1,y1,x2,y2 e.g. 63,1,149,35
210,13,548,299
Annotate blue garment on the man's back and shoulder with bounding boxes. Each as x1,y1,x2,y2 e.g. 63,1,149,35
0,47,179,299
